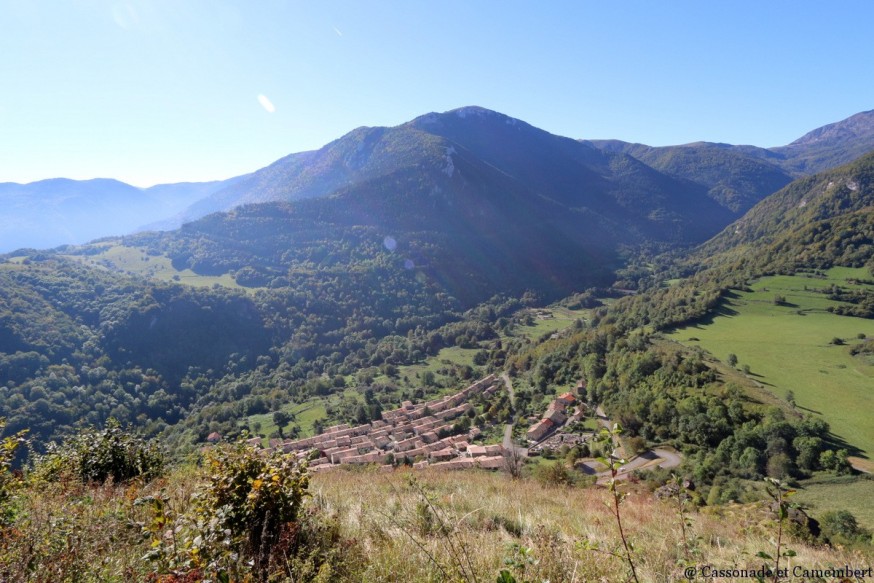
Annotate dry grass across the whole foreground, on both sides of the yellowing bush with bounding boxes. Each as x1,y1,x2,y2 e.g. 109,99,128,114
0,469,874,583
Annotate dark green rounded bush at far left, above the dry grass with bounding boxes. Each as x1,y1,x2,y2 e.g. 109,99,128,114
31,419,164,483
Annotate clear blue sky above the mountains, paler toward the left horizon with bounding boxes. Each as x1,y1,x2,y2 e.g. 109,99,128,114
0,0,874,186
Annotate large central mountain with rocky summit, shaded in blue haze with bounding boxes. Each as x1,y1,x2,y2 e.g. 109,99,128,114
112,107,752,305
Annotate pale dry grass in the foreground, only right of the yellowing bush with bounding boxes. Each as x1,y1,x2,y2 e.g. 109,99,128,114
311,471,872,582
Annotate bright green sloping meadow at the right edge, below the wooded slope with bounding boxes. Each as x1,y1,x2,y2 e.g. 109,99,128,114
667,268,874,458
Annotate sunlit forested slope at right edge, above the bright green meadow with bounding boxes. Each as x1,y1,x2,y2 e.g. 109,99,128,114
611,153,874,336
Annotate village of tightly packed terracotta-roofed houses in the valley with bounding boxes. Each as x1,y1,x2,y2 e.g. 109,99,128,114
251,375,585,472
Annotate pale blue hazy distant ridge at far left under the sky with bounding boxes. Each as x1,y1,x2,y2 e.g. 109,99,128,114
0,178,238,253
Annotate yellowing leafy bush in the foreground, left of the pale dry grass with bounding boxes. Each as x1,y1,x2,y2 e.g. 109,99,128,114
139,439,358,581
